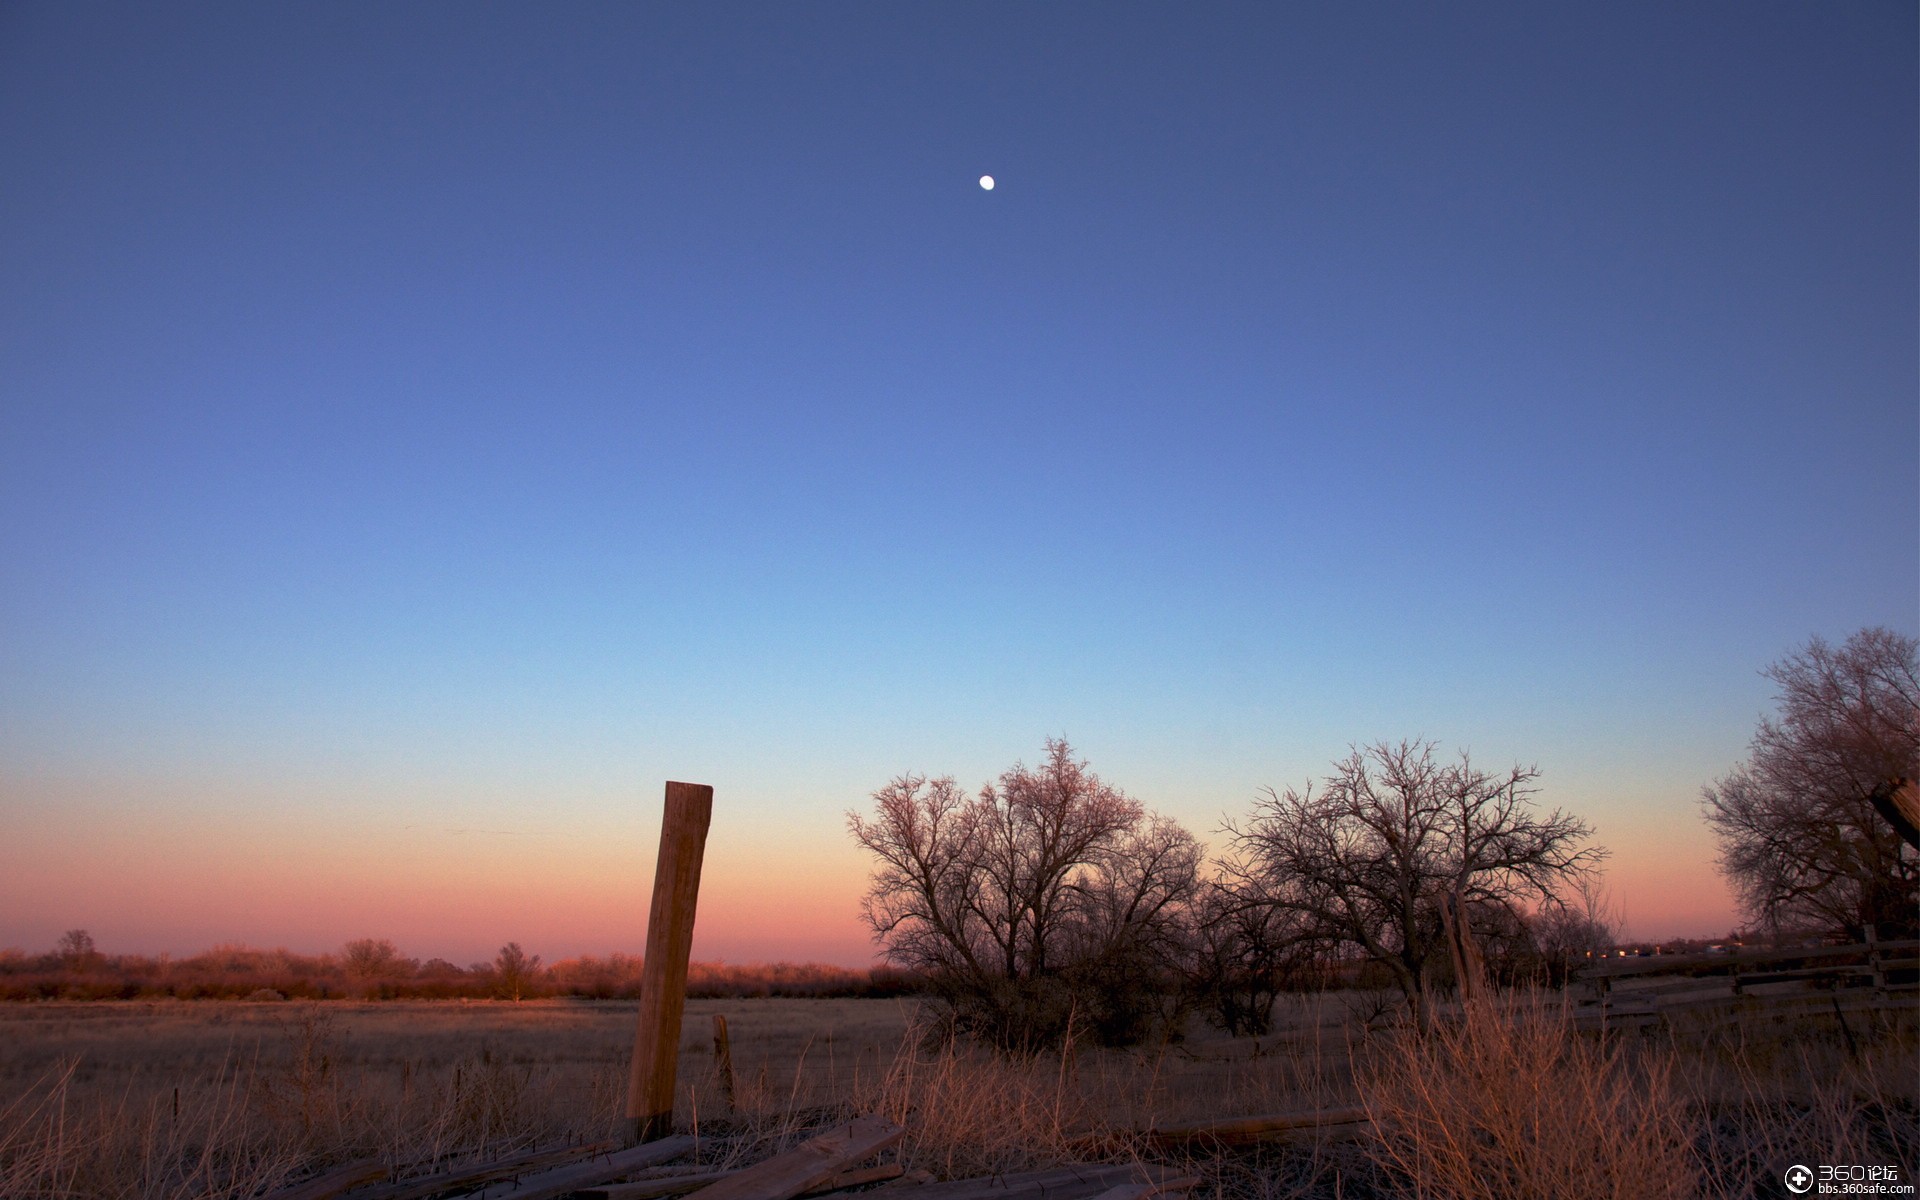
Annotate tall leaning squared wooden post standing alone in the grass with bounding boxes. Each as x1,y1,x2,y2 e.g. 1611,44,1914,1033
626,783,714,1142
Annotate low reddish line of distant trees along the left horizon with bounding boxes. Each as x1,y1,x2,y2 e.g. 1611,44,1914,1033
0,929,916,1000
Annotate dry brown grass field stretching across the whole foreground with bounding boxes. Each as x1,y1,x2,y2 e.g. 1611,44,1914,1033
0,993,1920,1200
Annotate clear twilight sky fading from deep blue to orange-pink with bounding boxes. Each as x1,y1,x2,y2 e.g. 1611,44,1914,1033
0,2,1920,964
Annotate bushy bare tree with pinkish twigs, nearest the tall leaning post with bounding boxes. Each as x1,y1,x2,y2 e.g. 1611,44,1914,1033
847,741,1200,1048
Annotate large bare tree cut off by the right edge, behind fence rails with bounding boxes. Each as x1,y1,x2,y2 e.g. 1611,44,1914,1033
1701,628,1920,935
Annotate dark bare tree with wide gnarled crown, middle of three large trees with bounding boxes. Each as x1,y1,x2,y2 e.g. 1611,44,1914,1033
1227,741,1605,1020
